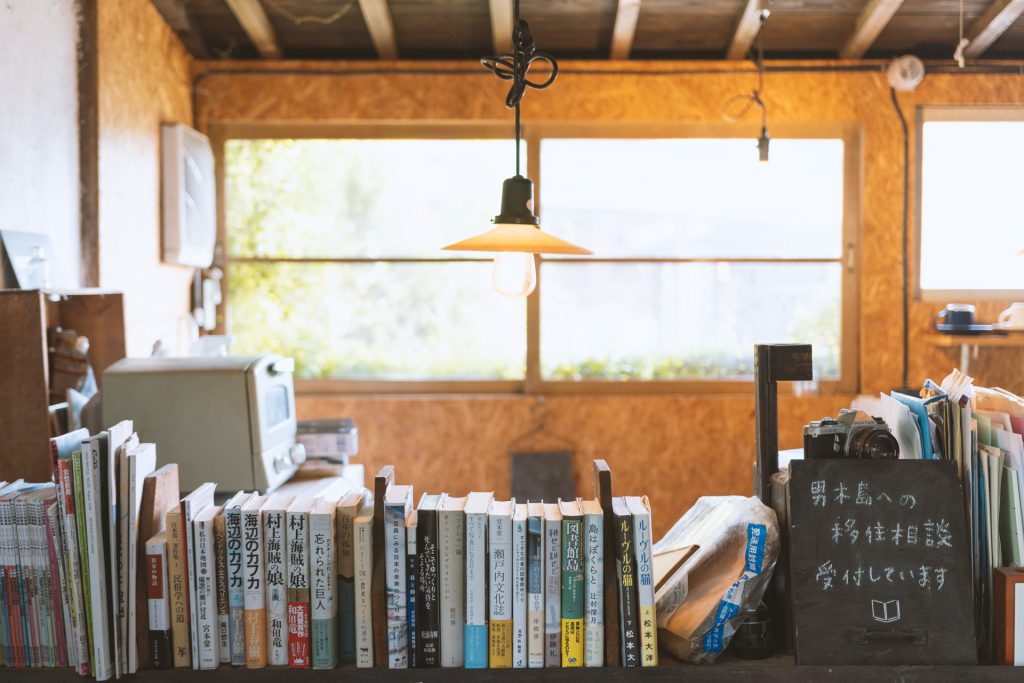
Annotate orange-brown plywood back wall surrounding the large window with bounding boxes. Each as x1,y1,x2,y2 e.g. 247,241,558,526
196,61,1024,531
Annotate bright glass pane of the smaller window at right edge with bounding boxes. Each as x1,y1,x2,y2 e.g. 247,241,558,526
921,121,1024,290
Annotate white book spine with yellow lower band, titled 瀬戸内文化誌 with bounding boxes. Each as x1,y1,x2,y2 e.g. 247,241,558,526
487,515,513,669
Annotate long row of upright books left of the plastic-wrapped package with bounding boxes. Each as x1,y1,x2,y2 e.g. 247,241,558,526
0,421,657,680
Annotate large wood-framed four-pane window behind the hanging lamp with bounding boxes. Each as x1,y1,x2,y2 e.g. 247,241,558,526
220,126,856,392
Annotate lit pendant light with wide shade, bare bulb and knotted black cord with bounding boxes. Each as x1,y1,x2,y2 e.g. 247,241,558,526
444,0,592,297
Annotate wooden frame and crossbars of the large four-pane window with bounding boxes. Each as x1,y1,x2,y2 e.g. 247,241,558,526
208,121,862,395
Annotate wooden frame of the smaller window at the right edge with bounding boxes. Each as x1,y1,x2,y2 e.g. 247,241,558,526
912,104,1024,303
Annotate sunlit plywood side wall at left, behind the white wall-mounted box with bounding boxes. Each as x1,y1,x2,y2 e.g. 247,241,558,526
98,0,191,355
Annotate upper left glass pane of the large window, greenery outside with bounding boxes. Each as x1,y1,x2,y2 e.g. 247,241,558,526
224,139,525,258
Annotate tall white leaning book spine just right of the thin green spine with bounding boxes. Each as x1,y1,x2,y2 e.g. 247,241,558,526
82,441,114,681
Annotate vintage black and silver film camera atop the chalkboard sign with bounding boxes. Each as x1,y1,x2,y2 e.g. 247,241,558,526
804,409,899,460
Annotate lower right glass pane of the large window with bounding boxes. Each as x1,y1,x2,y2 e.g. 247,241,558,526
541,261,842,380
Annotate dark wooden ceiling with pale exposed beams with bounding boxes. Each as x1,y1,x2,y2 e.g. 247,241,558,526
152,0,1024,59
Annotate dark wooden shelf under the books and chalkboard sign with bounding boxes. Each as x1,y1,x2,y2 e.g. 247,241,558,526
0,655,1021,683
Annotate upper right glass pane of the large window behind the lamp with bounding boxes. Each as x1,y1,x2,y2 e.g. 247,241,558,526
540,139,843,259
